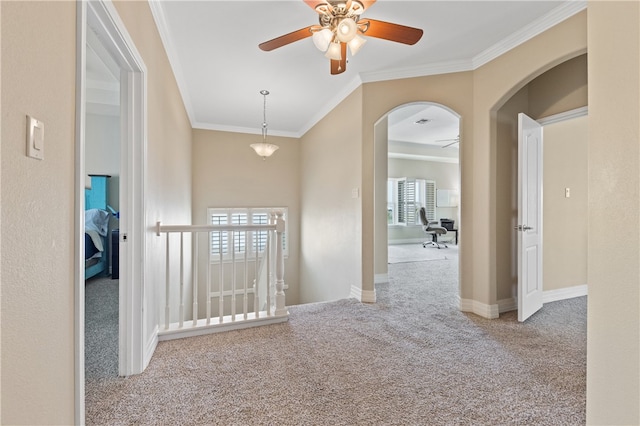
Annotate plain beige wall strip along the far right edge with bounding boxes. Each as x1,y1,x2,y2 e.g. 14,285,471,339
587,1,640,425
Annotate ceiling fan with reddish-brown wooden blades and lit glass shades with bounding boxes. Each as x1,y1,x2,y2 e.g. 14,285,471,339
258,0,423,75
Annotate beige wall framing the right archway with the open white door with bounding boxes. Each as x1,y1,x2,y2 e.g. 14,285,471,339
472,12,587,310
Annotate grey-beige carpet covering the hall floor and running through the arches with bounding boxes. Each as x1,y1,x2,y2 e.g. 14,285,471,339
86,255,586,425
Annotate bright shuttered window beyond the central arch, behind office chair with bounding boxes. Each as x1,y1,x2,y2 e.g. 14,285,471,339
387,178,436,226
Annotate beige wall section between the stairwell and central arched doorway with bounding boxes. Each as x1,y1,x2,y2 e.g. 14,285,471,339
300,88,362,303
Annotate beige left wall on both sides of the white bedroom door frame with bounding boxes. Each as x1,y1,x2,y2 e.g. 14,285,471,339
1,1,191,424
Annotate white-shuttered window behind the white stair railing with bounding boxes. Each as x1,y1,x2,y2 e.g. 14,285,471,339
207,207,289,261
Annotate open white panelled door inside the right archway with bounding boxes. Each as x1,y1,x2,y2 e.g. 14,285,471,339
516,113,542,321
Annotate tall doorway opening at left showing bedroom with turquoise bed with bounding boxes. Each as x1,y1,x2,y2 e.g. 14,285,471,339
84,28,122,381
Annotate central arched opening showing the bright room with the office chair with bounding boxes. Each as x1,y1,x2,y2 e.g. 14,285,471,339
374,102,461,298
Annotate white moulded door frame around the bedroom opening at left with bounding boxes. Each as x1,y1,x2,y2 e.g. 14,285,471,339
74,0,149,424
